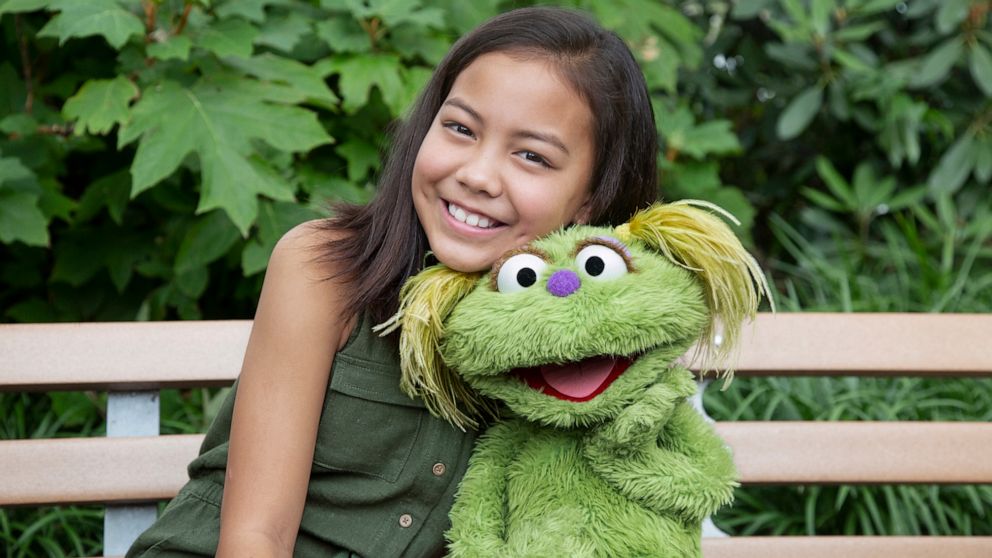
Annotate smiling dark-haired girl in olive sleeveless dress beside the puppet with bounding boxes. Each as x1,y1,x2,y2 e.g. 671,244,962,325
128,8,657,557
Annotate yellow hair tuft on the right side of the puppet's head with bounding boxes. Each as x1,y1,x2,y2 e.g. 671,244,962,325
616,200,775,378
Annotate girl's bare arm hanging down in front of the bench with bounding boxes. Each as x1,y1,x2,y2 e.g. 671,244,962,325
217,223,353,557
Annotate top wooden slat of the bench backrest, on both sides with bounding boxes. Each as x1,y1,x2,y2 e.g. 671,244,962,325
0,313,992,391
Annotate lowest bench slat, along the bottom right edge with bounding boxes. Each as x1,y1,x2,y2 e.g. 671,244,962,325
703,537,992,558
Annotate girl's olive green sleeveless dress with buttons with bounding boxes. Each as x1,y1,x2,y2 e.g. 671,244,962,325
127,317,475,558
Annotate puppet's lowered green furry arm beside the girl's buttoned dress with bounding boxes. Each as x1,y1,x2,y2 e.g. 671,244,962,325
445,420,527,558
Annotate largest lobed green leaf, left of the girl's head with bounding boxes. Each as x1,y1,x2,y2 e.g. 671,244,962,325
120,82,331,234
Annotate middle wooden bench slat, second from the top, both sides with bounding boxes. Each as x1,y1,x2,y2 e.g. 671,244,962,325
7,422,992,505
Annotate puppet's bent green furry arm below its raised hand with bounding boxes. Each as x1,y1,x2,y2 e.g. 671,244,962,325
591,403,738,522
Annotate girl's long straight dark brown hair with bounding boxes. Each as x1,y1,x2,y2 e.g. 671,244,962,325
318,7,658,322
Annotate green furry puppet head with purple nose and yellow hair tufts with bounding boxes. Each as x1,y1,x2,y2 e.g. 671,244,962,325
380,201,767,434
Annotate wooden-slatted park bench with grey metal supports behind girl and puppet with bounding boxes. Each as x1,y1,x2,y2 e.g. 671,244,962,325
0,314,992,558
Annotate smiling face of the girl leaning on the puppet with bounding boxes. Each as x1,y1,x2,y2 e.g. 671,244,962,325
413,53,595,271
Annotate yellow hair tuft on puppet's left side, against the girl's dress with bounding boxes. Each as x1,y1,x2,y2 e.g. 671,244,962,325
373,264,494,430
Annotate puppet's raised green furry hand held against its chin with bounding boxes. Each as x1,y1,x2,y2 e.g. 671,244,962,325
586,367,696,459
